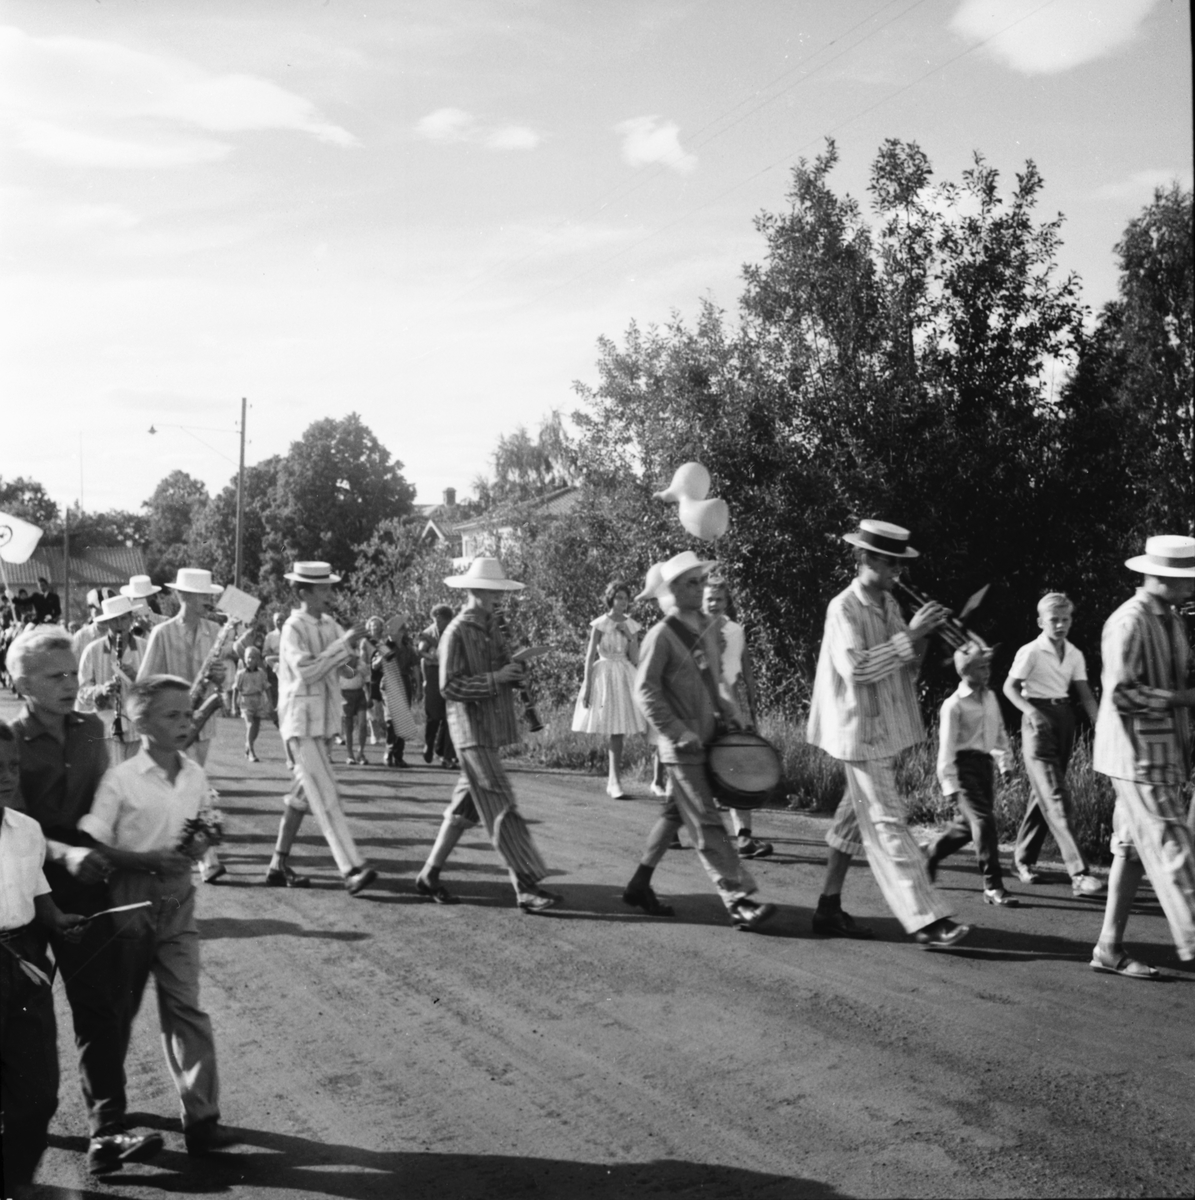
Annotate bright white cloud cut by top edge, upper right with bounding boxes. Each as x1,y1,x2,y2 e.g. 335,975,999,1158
950,0,1155,74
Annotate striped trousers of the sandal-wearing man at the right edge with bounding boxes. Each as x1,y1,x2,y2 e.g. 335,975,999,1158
1111,779,1195,962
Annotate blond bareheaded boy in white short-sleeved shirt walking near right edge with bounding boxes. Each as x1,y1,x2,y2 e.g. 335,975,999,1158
1004,592,1105,899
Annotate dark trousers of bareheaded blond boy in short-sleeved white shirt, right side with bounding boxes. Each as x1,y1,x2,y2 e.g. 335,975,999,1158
1014,704,1087,875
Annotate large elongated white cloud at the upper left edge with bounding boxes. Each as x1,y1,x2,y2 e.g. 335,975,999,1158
0,26,358,169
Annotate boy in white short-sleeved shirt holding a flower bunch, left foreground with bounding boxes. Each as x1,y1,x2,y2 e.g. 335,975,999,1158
79,676,236,1154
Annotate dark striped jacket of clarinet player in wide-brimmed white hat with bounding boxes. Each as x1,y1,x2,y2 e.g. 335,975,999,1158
440,608,518,750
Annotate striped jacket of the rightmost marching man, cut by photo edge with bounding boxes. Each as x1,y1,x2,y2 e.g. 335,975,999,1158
1093,588,1191,785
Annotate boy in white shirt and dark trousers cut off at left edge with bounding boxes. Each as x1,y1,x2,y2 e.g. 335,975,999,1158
0,721,85,1196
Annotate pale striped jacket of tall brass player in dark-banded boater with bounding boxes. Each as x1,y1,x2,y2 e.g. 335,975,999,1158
805,580,925,762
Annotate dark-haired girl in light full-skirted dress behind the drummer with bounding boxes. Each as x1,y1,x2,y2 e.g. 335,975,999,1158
572,580,647,800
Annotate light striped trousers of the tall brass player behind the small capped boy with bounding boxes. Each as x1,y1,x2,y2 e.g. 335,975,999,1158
825,758,951,934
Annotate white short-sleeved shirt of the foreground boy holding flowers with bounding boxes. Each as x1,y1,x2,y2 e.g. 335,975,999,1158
79,746,210,854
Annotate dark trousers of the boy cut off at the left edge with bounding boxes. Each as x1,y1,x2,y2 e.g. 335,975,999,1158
0,925,58,1196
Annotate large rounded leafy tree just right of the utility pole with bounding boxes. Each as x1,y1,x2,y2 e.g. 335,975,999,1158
259,413,414,590
